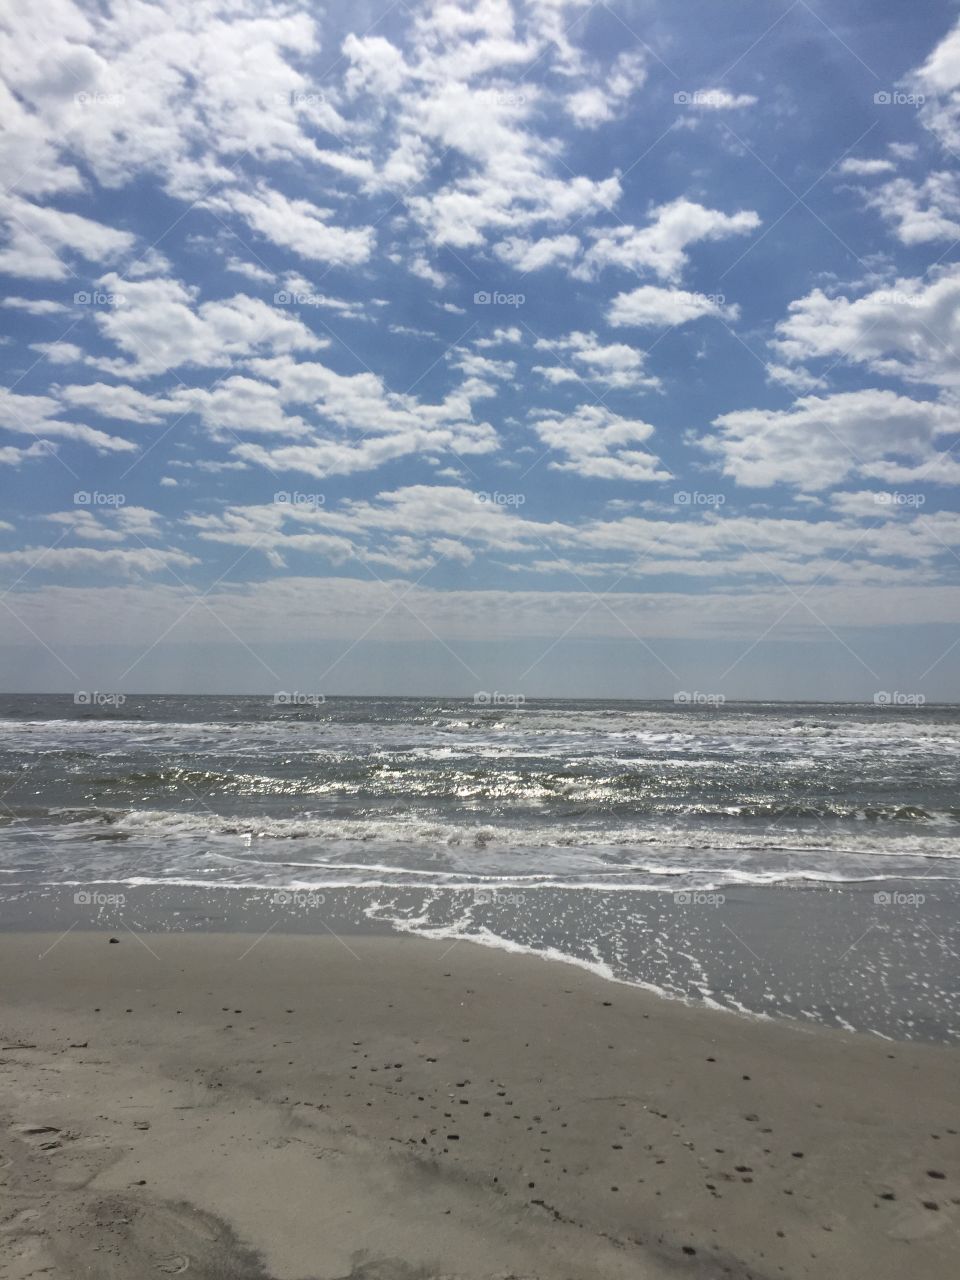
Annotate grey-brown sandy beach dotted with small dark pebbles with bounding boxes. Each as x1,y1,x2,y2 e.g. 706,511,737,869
0,931,960,1280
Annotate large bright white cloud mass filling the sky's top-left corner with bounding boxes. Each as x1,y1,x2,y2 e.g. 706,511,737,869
0,0,346,200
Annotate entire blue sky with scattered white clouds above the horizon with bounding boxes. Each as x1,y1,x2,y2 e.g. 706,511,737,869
0,0,960,705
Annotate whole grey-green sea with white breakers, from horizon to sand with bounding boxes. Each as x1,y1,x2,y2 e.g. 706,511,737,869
0,695,960,1041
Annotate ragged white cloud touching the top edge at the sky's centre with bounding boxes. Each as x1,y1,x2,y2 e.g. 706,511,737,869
344,0,624,248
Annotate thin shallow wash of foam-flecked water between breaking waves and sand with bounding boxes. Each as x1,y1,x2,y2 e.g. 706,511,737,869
0,879,960,1044
